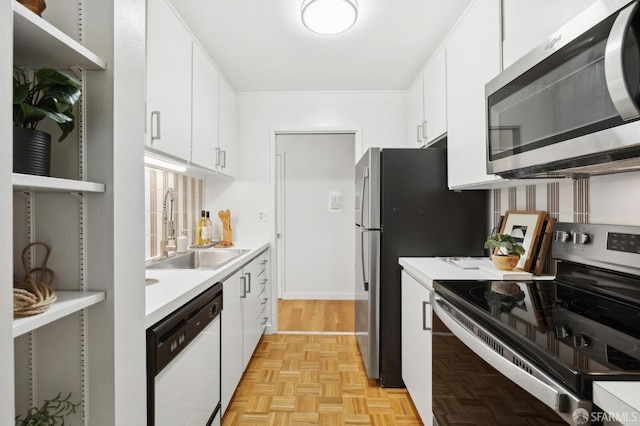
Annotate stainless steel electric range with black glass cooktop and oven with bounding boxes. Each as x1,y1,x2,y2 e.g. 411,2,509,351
432,222,640,426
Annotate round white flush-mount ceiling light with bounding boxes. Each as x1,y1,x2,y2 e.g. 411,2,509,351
301,0,358,35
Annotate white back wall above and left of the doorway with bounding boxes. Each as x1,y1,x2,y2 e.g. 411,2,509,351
204,92,407,246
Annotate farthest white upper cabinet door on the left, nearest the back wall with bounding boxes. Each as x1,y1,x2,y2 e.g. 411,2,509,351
217,78,238,176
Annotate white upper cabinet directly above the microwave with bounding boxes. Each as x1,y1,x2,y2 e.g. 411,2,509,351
502,0,595,68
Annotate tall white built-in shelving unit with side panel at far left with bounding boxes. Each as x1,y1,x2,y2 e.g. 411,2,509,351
5,0,146,426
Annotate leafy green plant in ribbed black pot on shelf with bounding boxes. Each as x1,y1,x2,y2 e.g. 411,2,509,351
13,66,80,176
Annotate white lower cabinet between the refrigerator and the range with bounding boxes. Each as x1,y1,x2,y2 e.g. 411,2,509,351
402,271,432,425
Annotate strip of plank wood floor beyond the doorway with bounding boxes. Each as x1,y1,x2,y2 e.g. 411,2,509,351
278,299,355,333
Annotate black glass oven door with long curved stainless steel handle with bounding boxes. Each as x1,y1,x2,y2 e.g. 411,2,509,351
432,293,592,426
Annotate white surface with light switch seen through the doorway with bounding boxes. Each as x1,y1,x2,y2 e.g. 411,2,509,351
276,133,355,300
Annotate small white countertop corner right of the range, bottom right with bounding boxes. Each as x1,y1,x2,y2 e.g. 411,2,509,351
593,381,640,426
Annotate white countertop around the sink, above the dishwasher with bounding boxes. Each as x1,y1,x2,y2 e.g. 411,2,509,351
145,242,269,328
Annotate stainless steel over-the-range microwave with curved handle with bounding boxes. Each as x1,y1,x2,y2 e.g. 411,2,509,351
485,0,640,178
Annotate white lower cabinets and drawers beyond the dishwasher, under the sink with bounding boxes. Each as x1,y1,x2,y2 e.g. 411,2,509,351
221,249,270,414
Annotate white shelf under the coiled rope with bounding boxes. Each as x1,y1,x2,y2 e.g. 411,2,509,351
13,291,105,337
